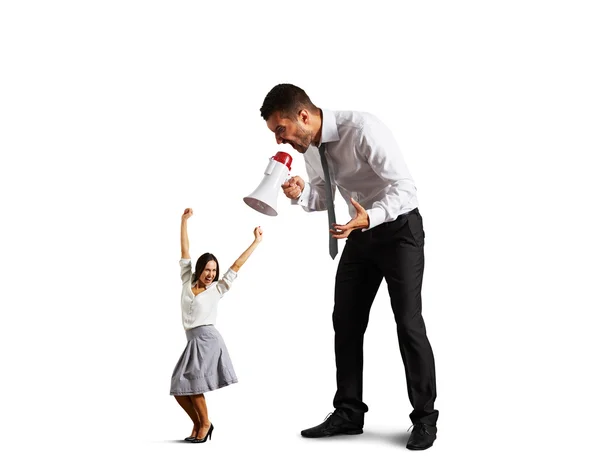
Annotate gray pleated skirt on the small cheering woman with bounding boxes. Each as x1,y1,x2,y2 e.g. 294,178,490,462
171,325,237,396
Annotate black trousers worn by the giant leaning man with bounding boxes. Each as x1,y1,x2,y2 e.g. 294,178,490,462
333,209,438,425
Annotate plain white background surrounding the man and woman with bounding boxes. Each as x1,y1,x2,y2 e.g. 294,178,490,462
0,0,600,465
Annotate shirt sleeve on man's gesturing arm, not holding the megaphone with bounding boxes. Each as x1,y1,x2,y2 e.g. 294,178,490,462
358,121,416,231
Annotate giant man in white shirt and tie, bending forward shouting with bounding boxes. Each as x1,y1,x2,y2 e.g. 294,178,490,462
260,84,438,450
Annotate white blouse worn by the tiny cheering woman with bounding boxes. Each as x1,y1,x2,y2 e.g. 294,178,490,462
179,259,237,330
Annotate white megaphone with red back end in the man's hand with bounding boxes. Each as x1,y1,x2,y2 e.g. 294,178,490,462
244,152,292,217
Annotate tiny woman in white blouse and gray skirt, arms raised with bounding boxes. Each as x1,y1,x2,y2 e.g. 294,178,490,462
171,208,262,443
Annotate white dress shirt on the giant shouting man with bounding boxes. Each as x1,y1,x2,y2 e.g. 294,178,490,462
292,109,418,230
